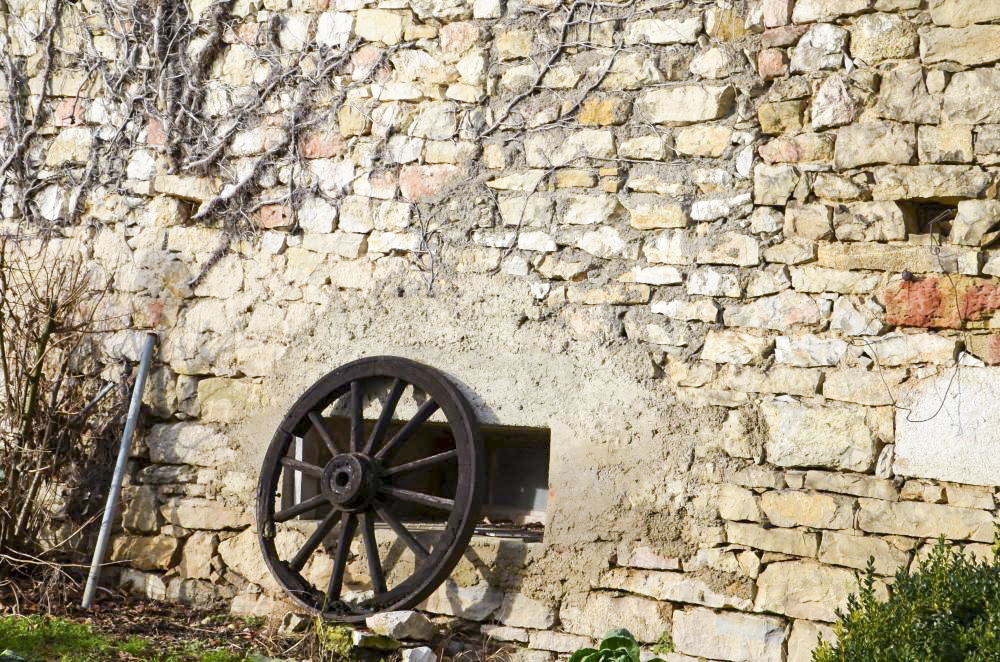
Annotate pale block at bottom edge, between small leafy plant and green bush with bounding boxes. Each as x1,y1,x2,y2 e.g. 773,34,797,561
671,608,786,662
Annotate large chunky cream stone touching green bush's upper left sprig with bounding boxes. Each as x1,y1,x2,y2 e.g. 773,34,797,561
754,564,856,622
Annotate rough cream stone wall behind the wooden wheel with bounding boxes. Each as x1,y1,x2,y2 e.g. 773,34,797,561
9,0,1000,662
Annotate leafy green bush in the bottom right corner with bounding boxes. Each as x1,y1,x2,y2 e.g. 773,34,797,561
813,538,1000,662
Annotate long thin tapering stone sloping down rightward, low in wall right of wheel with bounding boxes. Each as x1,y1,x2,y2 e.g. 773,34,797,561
598,568,753,610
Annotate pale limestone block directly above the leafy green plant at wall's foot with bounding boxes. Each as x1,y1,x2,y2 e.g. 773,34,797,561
559,592,673,642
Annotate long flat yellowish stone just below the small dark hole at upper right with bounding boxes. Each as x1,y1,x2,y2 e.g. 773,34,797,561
818,242,979,274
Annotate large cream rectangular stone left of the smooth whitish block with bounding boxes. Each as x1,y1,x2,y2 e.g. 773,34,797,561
761,401,876,471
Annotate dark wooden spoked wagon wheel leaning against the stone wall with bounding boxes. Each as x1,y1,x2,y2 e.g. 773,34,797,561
257,356,486,622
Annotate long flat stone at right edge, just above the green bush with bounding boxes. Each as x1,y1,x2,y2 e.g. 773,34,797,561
858,500,995,542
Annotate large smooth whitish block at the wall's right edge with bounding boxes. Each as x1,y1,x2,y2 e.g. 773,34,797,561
893,368,1000,488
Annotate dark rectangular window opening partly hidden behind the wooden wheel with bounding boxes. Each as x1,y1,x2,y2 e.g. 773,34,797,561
281,416,550,539
